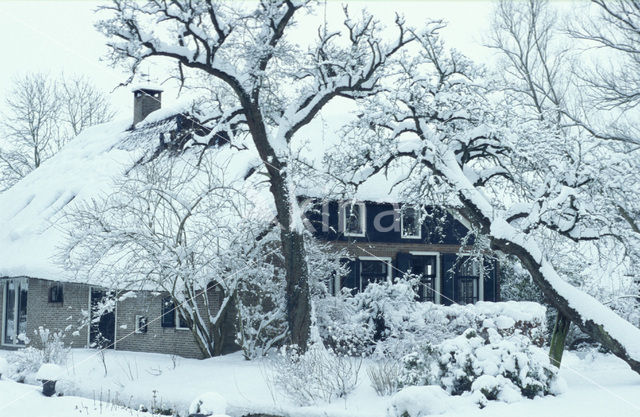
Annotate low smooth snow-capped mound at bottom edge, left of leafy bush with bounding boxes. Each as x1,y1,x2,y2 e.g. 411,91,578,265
387,385,451,417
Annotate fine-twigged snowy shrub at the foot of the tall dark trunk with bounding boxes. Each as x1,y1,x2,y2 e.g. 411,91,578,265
268,343,362,405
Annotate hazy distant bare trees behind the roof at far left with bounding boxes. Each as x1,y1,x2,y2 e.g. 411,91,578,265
0,73,114,190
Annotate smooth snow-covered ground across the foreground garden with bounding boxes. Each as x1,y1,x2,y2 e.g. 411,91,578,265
0,349,640,417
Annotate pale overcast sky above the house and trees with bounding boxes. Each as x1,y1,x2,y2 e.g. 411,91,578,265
0,0,502,115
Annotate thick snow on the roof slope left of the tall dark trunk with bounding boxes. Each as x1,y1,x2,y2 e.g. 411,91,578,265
0,109,267,281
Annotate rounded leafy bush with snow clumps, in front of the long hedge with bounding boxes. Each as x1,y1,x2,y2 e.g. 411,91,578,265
402,320,557,402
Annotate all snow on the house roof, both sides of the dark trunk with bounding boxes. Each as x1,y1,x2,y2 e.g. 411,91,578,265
0,96,420,281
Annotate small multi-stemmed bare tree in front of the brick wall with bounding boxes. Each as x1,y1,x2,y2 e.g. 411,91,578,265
61,148,286,357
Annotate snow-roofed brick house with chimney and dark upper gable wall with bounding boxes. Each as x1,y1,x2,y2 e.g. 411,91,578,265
0,86,498,357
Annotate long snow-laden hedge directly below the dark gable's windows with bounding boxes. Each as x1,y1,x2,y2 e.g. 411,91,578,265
316,279,546,358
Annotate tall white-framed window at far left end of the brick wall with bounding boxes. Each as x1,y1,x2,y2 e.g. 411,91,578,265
2,278,29,345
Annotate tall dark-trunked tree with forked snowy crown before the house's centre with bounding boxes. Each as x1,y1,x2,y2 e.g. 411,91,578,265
98,0,411,349
